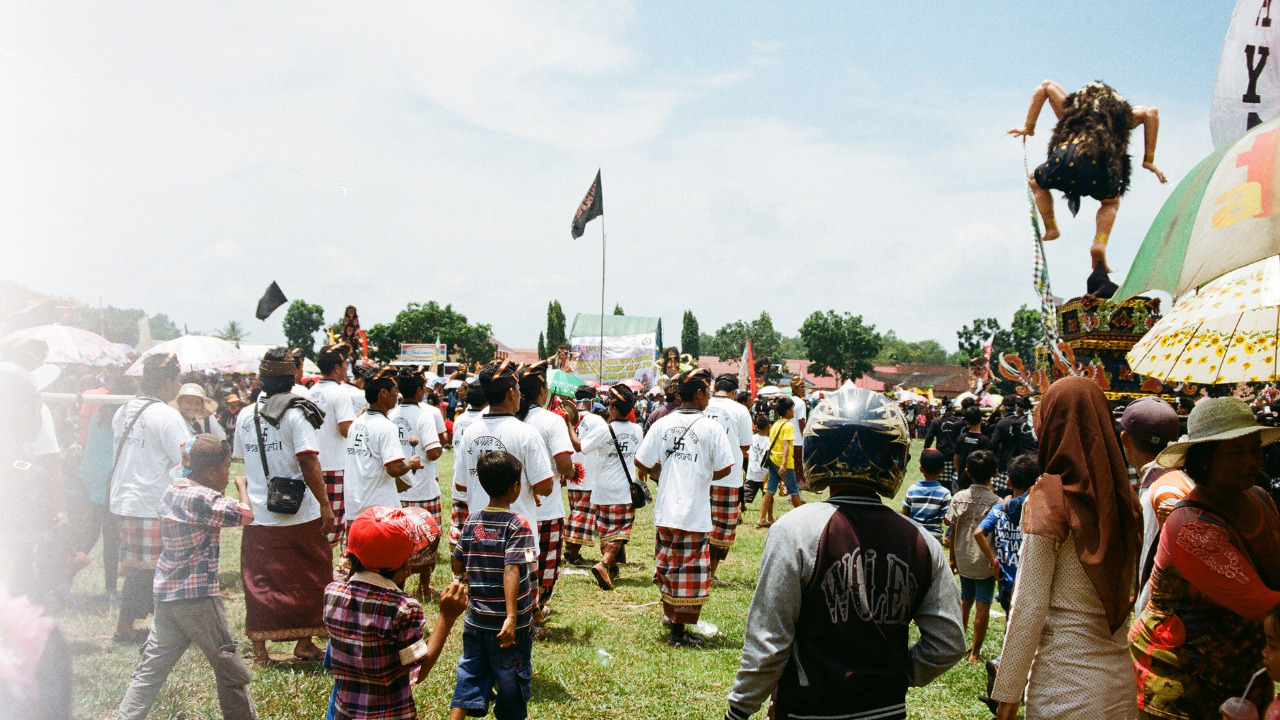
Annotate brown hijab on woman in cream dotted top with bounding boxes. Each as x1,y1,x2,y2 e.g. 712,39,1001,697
1023,377,1142,633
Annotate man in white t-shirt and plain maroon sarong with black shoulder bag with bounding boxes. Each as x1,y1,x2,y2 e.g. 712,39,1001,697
232,347,334,666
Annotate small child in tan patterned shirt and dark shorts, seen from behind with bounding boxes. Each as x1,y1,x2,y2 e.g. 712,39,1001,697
946,450,1000,662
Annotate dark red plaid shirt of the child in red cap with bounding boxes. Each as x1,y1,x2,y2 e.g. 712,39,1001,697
324,571,426,720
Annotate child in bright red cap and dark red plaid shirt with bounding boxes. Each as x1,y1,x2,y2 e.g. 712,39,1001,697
324,506,466,720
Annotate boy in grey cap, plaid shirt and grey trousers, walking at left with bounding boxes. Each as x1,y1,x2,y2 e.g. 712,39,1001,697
116,434,257,720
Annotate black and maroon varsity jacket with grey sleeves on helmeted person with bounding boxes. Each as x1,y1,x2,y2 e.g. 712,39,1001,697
724,495,965,720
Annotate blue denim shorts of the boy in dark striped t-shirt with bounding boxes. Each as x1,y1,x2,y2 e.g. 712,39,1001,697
449,628,534,720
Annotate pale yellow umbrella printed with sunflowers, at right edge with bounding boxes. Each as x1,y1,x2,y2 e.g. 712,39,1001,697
1128,258,1280,384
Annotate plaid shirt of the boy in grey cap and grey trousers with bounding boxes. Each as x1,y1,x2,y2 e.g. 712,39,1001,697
151,478,252,602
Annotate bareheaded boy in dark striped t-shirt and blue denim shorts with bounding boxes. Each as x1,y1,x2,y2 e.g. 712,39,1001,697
449,450,538,720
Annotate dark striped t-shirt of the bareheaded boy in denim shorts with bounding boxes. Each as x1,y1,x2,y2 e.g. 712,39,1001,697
453,507,538,633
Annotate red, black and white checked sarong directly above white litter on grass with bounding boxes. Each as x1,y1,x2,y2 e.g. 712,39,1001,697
653,527,712,625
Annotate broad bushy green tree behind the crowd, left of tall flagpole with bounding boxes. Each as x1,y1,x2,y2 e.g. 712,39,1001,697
366,300,497,364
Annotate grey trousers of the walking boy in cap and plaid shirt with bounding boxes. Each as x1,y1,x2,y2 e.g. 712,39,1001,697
116,597,257,720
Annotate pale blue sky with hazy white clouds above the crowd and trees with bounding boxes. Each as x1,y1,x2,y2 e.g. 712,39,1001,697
0,0,1233,348
